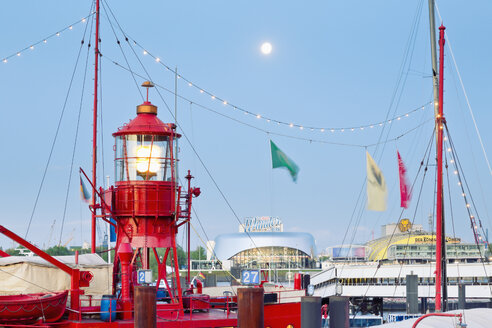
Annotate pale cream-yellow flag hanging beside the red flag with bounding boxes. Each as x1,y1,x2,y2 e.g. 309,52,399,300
366,151,387,212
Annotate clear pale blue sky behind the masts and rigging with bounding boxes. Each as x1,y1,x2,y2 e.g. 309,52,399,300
0,0,492,254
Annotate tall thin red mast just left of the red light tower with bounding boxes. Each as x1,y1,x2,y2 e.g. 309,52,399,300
91,0,99,253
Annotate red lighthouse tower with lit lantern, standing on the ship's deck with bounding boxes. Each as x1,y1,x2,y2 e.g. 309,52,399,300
106,82,200,313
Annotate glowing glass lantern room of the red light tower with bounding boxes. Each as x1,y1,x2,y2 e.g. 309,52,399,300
115,134,171,181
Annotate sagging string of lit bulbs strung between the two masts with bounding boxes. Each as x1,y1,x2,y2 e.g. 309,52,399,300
130,38,432,133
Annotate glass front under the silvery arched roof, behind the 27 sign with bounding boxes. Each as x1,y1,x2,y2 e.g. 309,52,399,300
230,246,315,269
